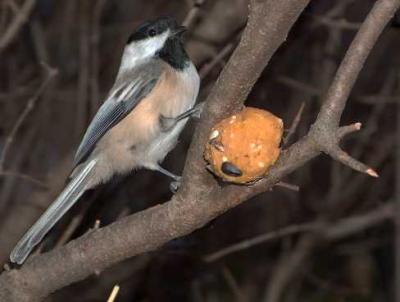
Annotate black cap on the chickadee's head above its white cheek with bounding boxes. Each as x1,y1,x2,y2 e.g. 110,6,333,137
127,17,186,44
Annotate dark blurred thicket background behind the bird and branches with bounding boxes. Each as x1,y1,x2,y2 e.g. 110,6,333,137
0,0,400,302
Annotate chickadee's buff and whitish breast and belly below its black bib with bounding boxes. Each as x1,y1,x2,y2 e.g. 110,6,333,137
94,60,200,182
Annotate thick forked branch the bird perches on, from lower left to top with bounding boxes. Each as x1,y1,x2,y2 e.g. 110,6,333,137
0,0,310,302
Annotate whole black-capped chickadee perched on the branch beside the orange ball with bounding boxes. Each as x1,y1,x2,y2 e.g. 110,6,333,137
10,17,200,264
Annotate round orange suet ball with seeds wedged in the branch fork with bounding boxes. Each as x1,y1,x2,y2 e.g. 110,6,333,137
204,107,283,184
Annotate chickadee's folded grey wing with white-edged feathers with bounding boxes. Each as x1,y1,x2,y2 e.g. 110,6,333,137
74,67,160,166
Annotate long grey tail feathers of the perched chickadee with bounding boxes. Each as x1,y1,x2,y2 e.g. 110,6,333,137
10,159,96,264
